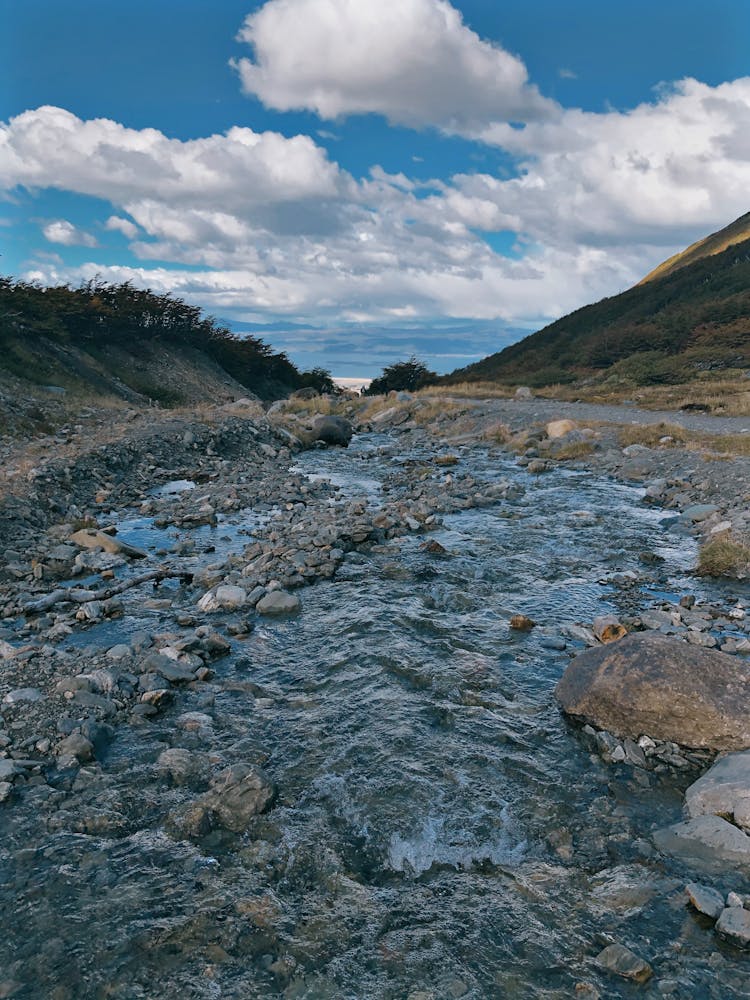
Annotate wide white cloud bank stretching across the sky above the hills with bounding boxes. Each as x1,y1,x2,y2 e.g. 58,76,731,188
0,79,750,340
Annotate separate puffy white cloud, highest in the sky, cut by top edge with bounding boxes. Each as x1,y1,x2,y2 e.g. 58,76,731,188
234,0,557,136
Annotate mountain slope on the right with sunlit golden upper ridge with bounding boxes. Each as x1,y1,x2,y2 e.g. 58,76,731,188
445,213,750,386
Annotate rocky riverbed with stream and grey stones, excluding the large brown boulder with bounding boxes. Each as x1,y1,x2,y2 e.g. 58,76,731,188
0,398,750,1000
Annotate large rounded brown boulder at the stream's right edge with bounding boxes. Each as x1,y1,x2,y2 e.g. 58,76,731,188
555,633,750,750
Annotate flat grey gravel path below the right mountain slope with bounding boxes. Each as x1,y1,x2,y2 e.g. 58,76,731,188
452,398,750,434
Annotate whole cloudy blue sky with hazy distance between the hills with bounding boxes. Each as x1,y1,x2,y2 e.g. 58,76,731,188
0,0,750,377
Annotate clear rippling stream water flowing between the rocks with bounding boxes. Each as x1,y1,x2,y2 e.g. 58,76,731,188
0,437,750,1000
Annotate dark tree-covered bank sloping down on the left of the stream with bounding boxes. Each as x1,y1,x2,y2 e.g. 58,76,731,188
0,277,328,406
